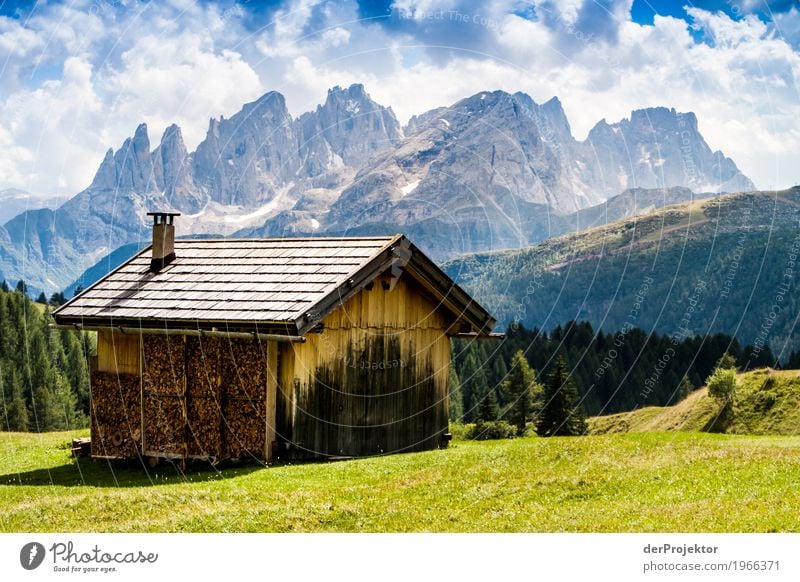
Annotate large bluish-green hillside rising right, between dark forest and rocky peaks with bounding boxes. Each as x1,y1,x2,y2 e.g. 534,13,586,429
445,187,800,357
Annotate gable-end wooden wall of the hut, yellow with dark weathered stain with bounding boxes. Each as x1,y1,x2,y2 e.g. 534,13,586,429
277,275,452,457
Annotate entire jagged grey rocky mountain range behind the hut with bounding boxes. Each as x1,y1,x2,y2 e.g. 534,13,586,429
0,85,754,292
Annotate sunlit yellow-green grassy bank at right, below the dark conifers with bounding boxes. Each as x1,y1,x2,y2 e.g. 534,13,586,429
589,369,800,435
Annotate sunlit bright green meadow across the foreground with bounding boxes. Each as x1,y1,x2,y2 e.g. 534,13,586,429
0,432,800,532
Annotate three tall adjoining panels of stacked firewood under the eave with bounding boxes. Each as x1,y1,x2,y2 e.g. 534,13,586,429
134,336,274,459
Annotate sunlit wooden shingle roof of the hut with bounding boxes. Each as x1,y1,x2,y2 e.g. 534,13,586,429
54,235,494,333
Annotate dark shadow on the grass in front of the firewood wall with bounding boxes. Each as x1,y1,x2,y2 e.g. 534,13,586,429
0,459,264,487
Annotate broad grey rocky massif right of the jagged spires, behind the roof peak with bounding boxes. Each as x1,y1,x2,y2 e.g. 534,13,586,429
247,91,754,259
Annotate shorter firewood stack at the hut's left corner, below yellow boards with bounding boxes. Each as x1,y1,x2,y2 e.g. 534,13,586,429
91,372,142,458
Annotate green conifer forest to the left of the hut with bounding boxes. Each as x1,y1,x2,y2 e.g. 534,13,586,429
0,282,92,432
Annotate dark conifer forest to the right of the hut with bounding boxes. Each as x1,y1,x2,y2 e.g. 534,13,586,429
450,321,780,422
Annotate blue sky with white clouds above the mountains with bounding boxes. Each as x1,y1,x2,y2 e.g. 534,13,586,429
0,0,800,196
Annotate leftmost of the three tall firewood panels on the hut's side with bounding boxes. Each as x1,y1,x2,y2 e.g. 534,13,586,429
142,336,186,456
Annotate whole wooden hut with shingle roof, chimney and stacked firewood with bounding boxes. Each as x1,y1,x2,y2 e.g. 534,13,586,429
54,213,495,461
